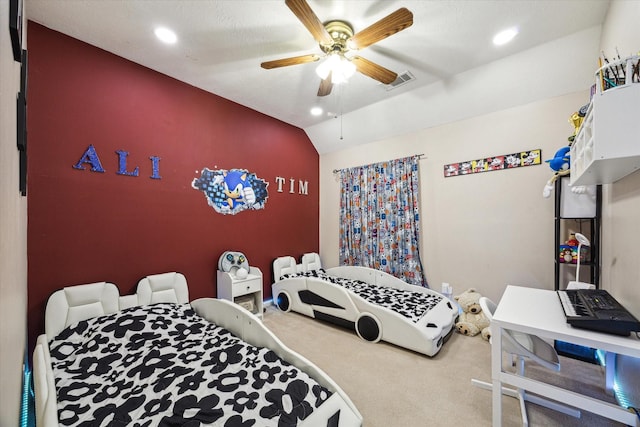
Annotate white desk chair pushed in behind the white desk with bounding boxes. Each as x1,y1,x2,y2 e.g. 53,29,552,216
471,297,580,427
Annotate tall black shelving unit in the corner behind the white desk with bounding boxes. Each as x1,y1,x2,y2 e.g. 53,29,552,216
553,176,602,290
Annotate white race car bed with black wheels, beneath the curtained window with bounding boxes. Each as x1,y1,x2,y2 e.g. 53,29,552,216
271,253,458,356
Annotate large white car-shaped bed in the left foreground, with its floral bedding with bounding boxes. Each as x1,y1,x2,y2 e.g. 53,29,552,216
33,273,362,427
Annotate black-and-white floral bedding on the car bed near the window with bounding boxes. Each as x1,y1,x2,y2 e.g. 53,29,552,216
281,269,444,323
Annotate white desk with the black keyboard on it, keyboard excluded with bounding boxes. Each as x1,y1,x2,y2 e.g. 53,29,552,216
491,286,640,427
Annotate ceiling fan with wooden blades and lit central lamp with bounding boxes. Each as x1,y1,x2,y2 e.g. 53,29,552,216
260,0,413,96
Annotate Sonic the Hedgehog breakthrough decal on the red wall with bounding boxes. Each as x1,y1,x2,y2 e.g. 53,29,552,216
191,168,269,215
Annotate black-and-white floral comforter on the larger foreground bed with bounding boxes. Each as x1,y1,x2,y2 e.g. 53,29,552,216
49,303,331,427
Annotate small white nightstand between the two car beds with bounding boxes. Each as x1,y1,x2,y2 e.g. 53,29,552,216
217,267,263,318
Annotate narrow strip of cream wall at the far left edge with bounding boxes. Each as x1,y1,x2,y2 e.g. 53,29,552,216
0,0,27,426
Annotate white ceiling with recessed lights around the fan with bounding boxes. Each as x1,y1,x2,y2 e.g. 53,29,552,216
25,0,609,153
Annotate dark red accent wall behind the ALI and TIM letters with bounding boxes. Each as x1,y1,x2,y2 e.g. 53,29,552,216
27,22,319,346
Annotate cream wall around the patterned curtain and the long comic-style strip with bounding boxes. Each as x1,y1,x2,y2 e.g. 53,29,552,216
320,90,589,300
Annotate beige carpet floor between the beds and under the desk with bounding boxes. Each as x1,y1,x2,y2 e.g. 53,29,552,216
264,306,622,427
